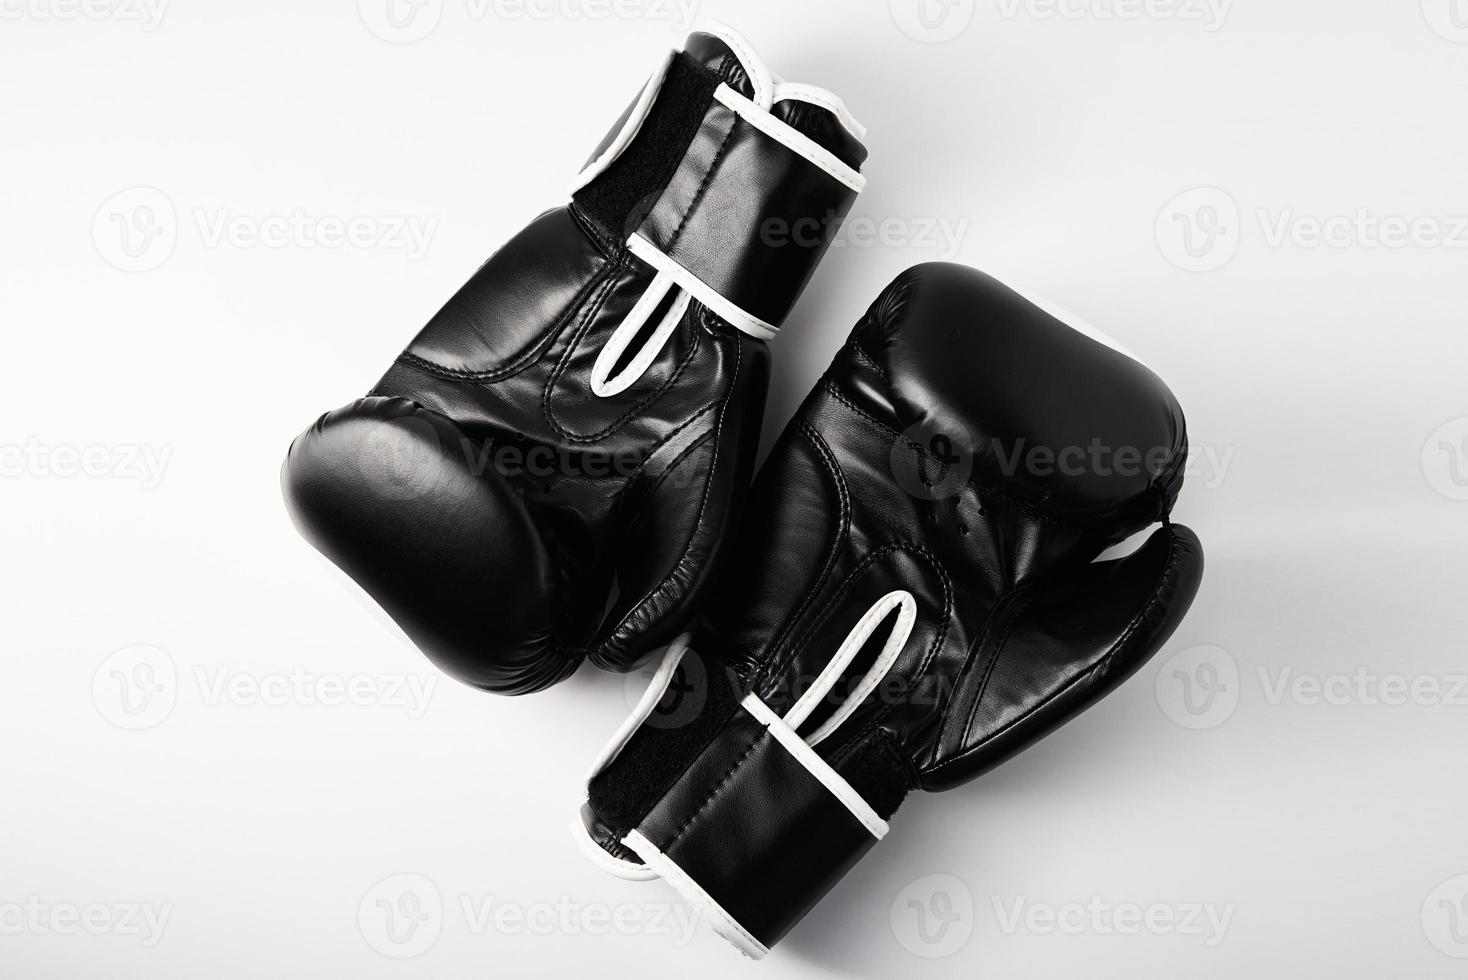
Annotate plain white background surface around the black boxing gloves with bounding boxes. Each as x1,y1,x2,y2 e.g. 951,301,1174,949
0,0,1468,980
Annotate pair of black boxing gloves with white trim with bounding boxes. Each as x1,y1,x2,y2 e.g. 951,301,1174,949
283,28,1202,957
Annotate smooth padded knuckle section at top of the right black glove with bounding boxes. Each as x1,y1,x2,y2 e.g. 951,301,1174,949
856,263,1186,533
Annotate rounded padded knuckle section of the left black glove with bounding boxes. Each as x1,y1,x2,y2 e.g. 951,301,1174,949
282,398,574,692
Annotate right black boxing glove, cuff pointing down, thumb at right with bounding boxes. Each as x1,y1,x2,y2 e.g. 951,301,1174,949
574,264,1202,957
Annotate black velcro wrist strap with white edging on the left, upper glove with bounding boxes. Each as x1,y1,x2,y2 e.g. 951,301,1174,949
574,53,865,339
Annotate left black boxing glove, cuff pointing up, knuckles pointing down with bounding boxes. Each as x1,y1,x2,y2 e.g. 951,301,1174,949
282,28,866,694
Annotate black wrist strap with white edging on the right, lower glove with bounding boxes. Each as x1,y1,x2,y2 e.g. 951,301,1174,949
622,695,887,958
